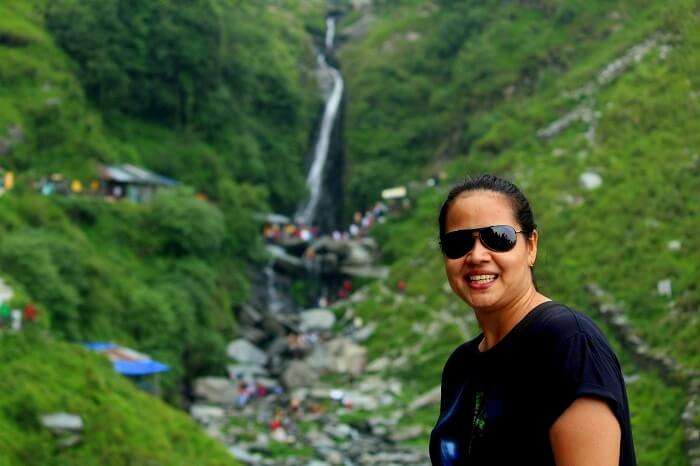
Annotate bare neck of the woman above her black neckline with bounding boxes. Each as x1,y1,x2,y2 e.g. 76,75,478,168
475,287,551,351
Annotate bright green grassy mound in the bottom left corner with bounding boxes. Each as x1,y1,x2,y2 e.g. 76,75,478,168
0,332,237,466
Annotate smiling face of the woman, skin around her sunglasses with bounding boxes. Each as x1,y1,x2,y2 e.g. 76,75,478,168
444,190,537,312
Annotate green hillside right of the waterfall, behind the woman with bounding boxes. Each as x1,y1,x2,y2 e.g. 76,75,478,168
341,1,700,465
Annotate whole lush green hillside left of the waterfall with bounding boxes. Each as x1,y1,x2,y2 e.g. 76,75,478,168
0,0,324,464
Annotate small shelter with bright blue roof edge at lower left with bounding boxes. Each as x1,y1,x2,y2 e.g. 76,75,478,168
85,342,170,395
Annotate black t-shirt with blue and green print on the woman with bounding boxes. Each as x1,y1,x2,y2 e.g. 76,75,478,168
430,301,636,466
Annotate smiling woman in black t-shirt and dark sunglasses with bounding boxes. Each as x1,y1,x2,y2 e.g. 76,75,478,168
430,175,636,466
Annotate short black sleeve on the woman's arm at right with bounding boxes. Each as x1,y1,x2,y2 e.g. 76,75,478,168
547,332,626,425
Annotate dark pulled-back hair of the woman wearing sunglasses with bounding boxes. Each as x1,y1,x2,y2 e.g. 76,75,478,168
438,175,537,288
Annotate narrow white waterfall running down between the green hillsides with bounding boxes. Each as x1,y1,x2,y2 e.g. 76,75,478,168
296,17,343,225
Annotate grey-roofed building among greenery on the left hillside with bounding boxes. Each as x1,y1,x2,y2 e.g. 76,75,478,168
99,164,178,202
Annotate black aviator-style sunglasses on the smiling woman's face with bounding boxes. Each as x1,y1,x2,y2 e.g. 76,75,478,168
440,225,524,259
